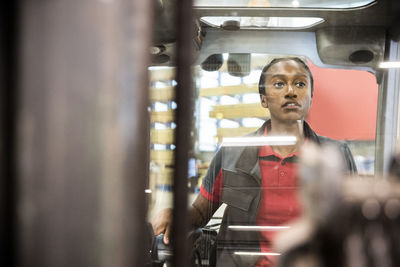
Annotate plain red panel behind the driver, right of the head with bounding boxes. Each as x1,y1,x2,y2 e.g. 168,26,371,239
307,62,378,140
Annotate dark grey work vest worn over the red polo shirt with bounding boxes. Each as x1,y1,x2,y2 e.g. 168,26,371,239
217,121,357,267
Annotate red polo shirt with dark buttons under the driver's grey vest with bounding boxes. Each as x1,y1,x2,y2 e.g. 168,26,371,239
200,127,307,267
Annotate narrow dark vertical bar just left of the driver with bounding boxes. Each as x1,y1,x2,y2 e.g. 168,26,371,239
172,0,194,267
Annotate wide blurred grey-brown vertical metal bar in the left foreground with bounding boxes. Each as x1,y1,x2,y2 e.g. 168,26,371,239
16,0,152,267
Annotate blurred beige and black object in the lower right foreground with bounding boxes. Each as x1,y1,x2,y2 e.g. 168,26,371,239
276,145,400,267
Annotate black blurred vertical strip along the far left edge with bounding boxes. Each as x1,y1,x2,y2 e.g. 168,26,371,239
0,1,18,266
